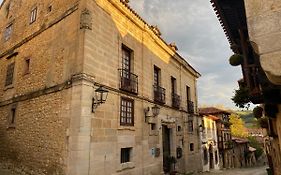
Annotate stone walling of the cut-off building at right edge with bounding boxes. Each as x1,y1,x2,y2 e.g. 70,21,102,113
242,0,281,174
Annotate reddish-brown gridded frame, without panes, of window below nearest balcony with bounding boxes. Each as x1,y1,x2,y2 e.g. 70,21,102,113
120,97,134,126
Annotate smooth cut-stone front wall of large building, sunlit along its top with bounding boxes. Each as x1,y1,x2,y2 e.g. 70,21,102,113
79,0,201,175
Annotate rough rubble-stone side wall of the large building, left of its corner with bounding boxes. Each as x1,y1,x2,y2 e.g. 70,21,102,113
0,0,81,175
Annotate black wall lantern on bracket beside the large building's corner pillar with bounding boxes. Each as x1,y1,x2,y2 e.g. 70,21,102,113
92,86,108,113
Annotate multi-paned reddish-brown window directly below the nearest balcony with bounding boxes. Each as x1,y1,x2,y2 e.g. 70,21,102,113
120,97,134,126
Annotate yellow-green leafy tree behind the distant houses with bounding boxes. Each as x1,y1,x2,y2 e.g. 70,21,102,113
229,114,248,137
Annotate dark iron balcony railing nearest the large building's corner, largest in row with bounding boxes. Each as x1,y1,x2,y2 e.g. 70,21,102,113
118,69,138,94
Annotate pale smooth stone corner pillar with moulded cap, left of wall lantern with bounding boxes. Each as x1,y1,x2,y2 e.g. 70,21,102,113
67,74,94,175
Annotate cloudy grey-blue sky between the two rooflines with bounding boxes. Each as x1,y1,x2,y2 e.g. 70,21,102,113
0,0,242,108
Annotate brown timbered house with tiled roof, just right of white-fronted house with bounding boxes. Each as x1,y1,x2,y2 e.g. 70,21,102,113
199,107,234,168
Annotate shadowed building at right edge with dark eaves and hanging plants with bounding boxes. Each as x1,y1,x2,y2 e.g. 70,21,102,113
211,0,281,175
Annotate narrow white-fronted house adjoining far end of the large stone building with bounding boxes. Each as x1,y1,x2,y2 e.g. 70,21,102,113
201,115,220,172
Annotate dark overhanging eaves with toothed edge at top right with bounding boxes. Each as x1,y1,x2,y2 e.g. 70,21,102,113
211,0,247,52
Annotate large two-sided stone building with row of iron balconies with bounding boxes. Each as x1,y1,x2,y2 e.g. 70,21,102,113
0,0,202,175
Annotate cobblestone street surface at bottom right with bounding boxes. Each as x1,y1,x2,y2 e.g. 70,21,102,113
199,166,267,175
